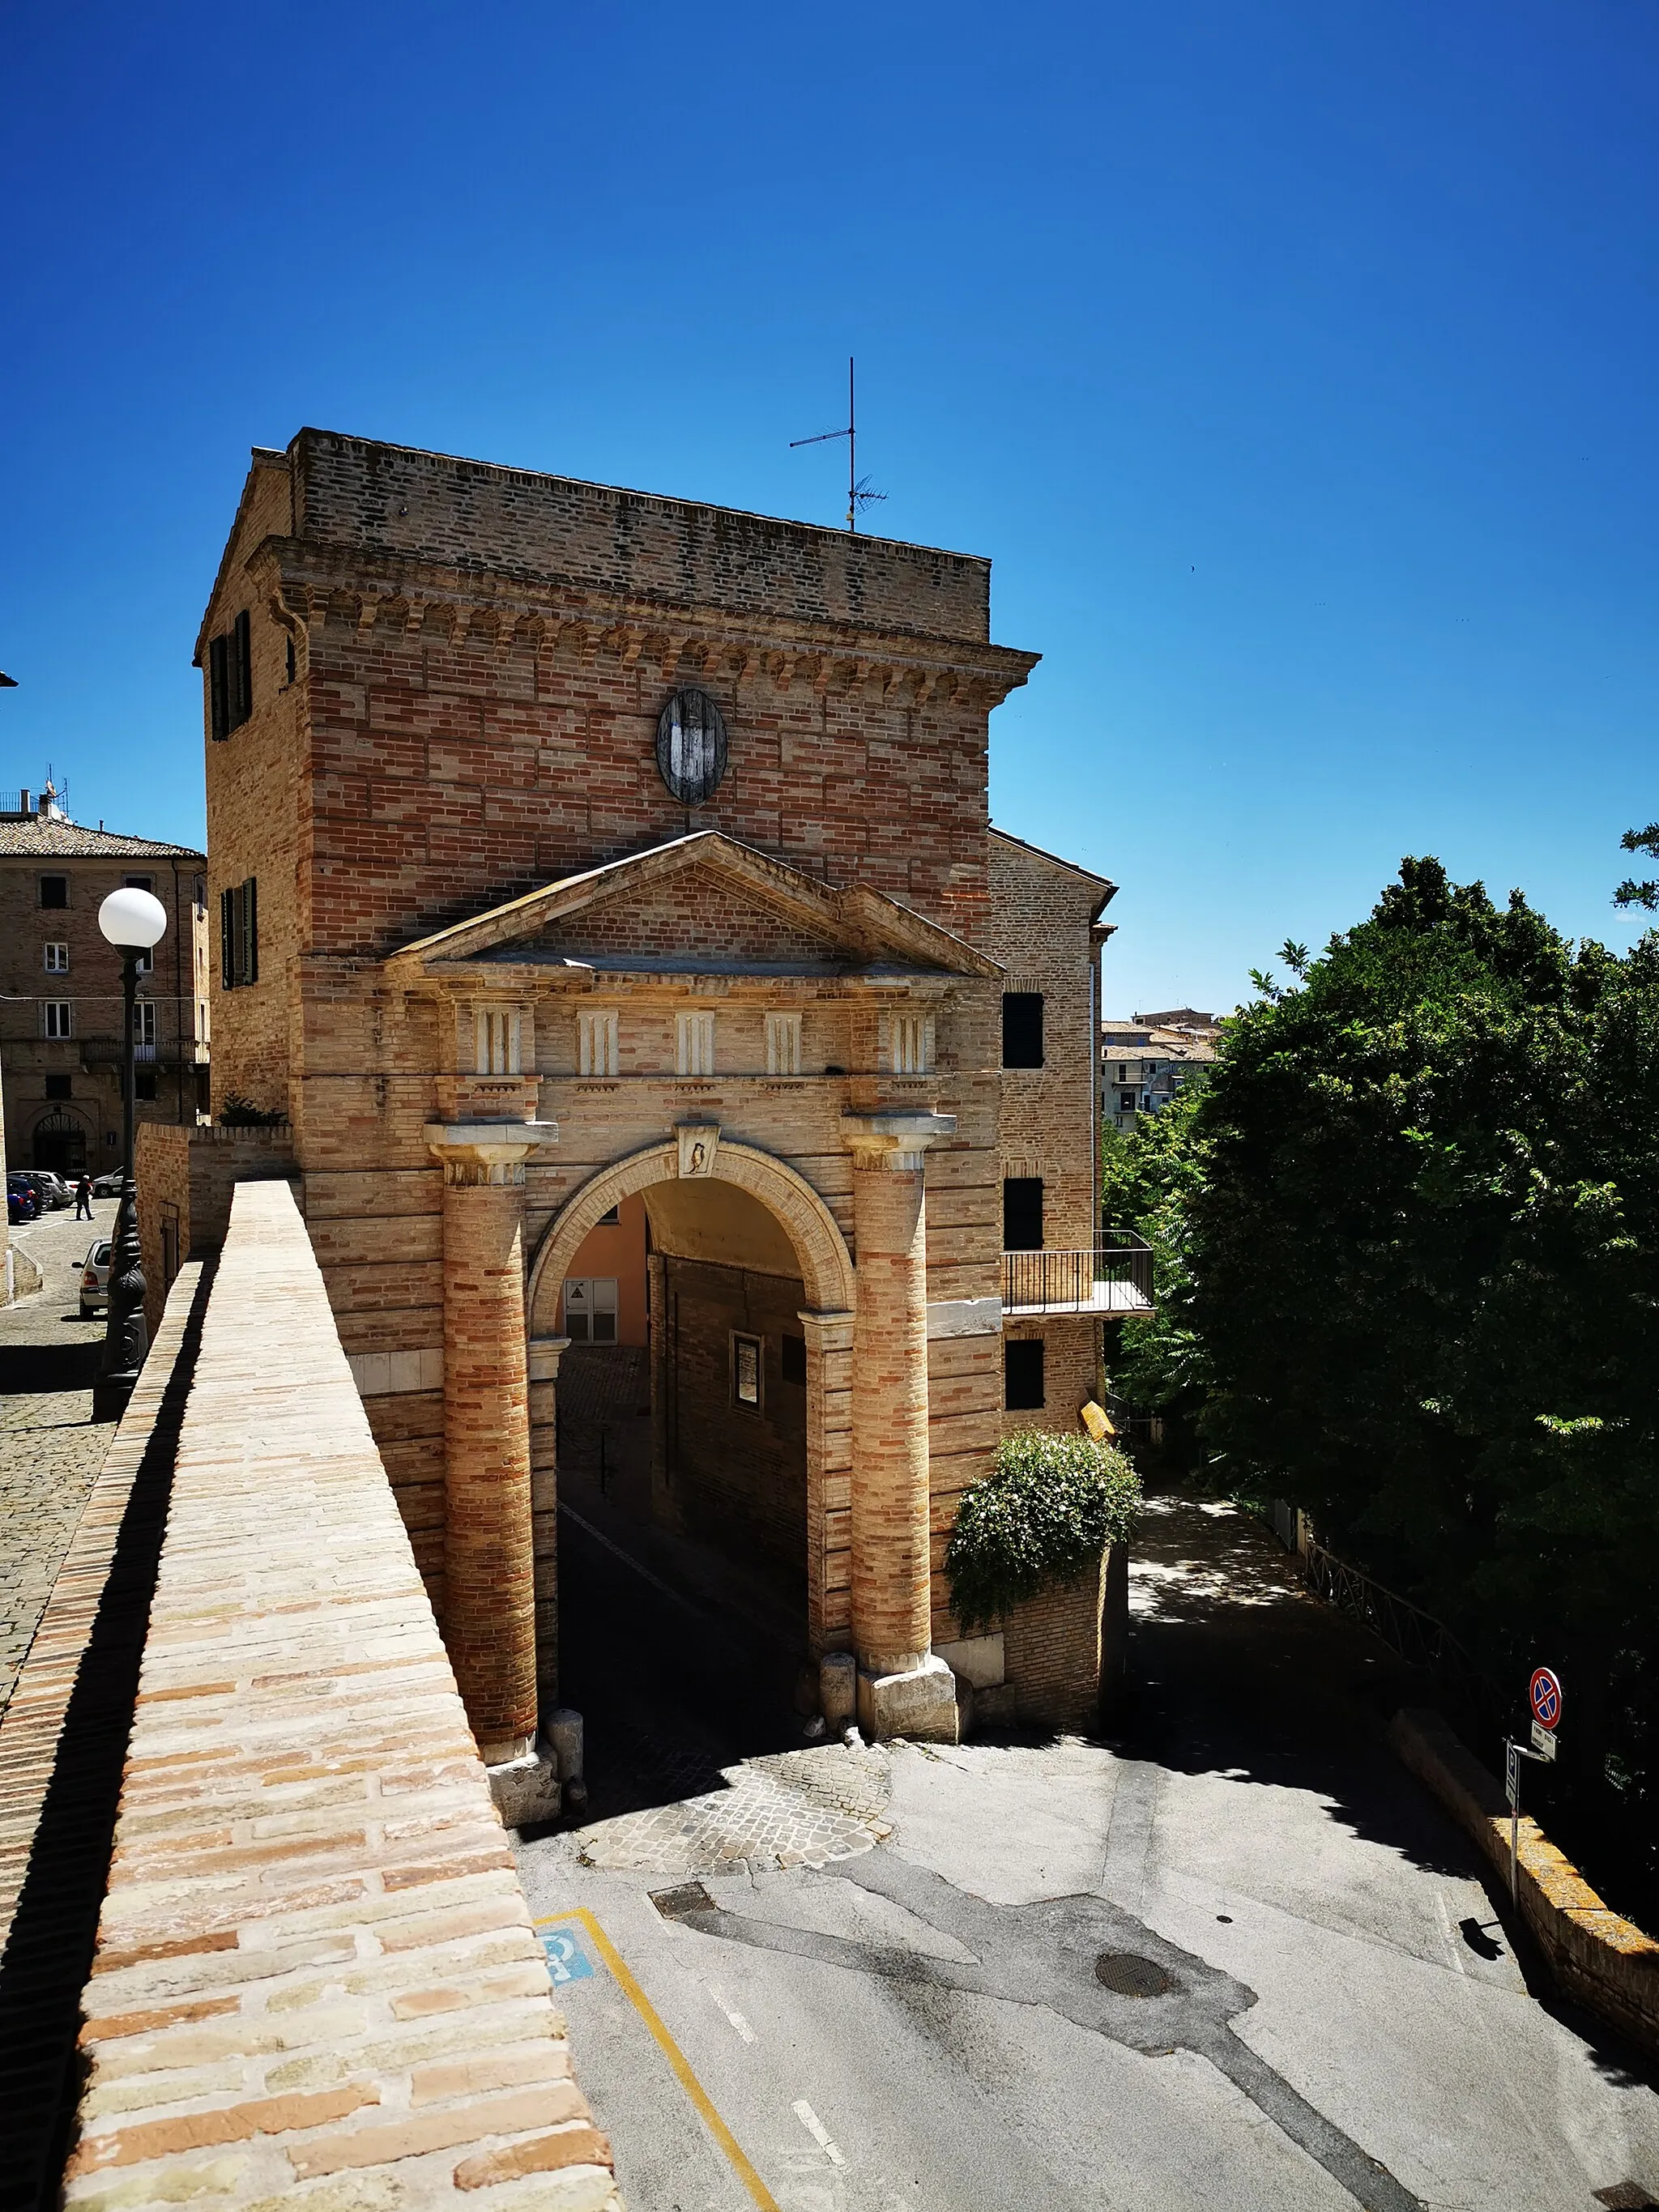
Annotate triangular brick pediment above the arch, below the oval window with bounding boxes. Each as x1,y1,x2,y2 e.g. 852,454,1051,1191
387,829,1002,975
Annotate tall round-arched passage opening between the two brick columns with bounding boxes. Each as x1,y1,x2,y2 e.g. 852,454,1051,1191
529,1146,851,1809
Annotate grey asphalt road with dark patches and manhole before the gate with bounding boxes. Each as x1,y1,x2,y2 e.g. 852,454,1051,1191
520,1500,1659,2212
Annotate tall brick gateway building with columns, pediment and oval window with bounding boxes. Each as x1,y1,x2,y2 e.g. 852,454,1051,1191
181,432,1113,1813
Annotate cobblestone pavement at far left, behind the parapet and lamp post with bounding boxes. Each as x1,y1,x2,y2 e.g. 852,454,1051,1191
0,1199,115,1712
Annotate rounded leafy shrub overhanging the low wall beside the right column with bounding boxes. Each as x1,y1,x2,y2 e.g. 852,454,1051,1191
945,1429,1141,1634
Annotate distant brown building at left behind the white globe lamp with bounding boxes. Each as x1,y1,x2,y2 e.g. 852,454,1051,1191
0,786,208,1177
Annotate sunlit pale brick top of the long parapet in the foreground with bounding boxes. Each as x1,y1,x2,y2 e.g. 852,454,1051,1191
64,1183,612,2212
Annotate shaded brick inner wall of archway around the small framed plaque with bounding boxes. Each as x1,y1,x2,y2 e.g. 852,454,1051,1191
666,1259,808,1586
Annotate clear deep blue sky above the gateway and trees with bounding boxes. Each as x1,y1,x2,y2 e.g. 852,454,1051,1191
0,0,1659,1011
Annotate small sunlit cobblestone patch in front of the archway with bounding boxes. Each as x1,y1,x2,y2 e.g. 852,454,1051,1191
571,1743,891,1873
